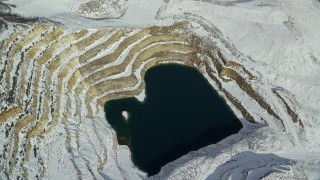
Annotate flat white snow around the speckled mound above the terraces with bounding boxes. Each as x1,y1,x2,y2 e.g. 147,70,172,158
9,0,163,29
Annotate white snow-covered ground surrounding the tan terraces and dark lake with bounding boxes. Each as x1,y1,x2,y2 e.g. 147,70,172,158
0,0,320,180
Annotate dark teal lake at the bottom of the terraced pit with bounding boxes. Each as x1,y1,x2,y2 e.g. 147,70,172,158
105,64,242,176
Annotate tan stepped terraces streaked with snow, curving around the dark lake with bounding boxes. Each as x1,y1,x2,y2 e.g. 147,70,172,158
0,22,303,179
